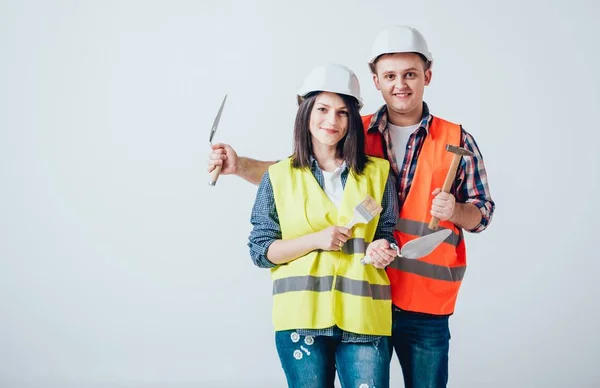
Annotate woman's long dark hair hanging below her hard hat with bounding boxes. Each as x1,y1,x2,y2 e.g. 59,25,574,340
292,92,368,175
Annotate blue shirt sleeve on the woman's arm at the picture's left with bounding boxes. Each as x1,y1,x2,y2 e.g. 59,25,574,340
248,171,281,268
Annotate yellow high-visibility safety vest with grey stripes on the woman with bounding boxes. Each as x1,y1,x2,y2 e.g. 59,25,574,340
269,157,392,336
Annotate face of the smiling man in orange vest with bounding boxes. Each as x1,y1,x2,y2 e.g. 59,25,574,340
373,53,431,115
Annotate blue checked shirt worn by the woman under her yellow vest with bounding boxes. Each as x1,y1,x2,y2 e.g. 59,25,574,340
248,157,399,342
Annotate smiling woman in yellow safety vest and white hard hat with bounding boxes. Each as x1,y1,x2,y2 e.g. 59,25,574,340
248,64,398,388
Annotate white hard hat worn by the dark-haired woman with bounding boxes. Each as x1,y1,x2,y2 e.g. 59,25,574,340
298,63,363,110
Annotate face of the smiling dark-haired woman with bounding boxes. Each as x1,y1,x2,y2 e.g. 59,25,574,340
309,92,348,146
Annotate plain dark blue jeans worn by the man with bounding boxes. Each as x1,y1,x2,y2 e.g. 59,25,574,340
390,308,450,388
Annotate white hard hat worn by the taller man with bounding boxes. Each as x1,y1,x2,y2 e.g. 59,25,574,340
369,26,433,65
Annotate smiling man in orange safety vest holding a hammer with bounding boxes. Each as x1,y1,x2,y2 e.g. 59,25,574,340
208,26,495,388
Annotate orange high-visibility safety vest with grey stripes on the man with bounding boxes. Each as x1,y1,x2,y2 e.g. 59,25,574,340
362,115,467,315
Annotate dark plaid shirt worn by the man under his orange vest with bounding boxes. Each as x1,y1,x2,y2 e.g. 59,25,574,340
368,102,495,233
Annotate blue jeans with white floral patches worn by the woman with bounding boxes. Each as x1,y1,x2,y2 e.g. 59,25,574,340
275,330,391,388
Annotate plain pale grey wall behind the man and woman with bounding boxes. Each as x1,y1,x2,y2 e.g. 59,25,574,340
0,0,600,388
